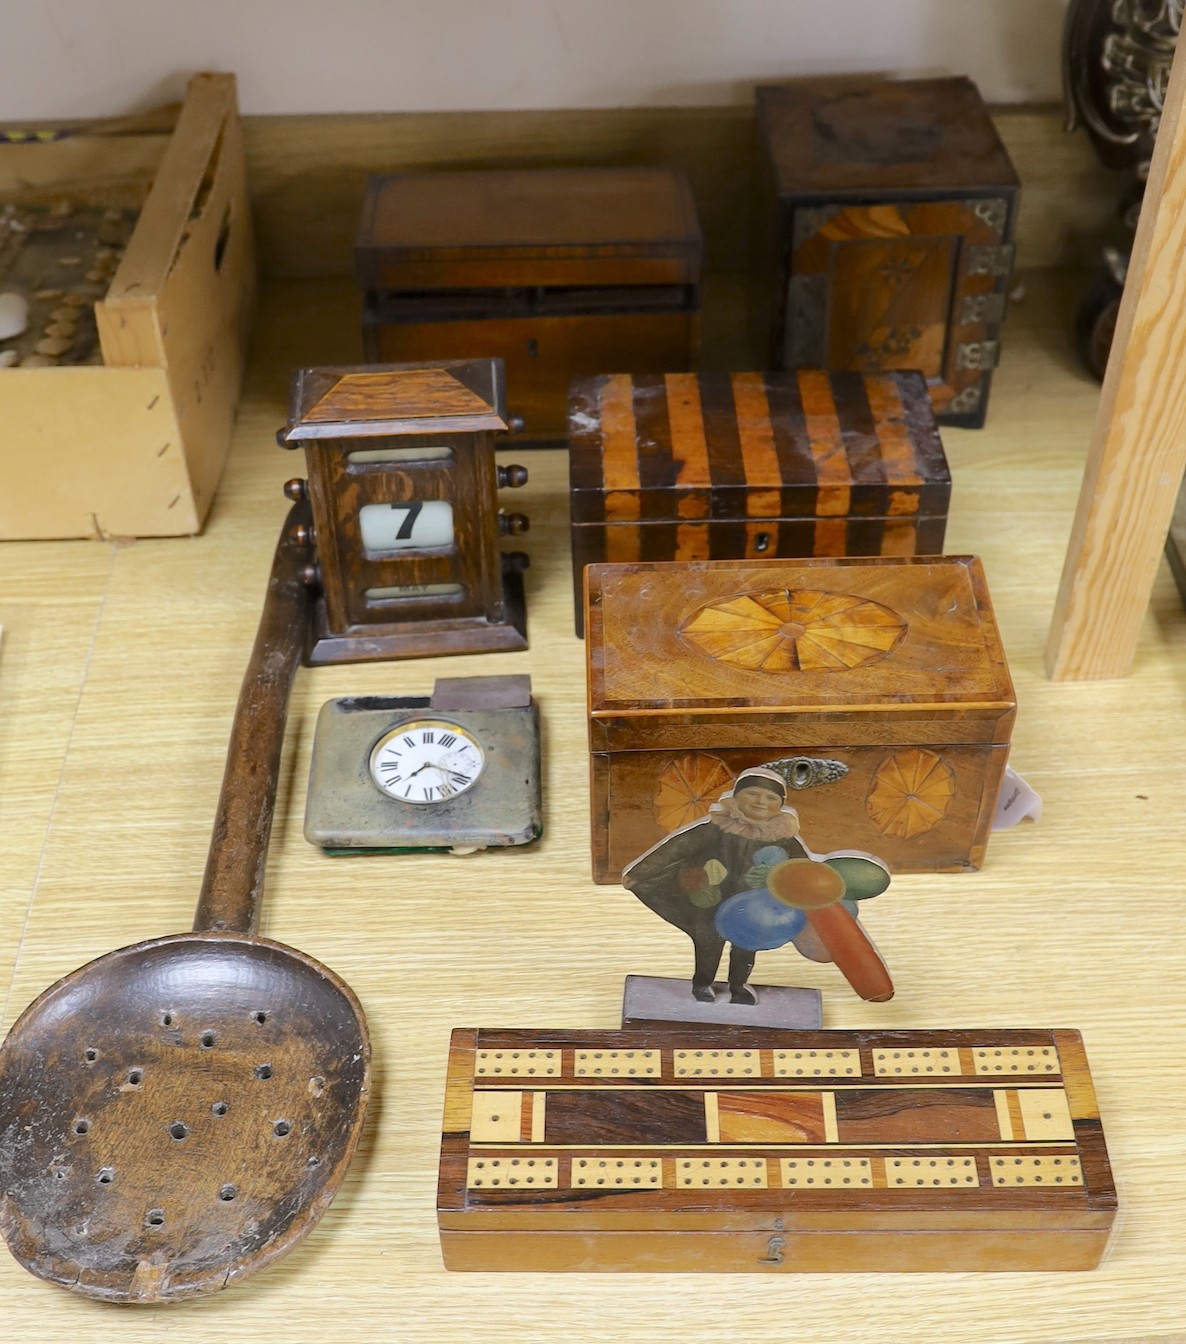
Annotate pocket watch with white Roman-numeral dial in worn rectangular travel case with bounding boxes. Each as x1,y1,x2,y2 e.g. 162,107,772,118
305,676,542,855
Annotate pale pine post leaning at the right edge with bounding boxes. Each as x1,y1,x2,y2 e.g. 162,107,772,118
1046,36,1186,681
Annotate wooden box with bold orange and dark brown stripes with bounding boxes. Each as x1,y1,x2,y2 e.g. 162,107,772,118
569,371,951,634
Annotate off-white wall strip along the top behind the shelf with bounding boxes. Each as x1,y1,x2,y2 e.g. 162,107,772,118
0,0,1066,121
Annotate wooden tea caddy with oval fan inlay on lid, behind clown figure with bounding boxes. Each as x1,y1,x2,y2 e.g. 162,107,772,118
585,556,1015,883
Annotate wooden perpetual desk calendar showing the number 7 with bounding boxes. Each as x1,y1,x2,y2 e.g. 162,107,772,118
278,359,528,664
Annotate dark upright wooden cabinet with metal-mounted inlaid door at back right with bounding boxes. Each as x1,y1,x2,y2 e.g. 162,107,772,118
753,78,1019,427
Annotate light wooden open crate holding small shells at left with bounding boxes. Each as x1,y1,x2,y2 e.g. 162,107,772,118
0,74,255,540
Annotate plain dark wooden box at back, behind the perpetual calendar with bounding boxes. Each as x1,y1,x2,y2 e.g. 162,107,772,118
355,168,701,442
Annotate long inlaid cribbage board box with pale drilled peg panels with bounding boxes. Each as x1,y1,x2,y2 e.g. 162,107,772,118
437,1027,1116,1273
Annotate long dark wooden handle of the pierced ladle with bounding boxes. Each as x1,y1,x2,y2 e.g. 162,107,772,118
194,501,313,933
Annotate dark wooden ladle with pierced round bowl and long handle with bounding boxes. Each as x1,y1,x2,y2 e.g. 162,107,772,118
0,504,370,1302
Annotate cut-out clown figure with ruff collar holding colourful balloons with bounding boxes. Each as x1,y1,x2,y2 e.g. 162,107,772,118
621,766,894,1004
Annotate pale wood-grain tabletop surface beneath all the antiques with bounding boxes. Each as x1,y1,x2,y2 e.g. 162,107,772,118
0,277,1186,1344
